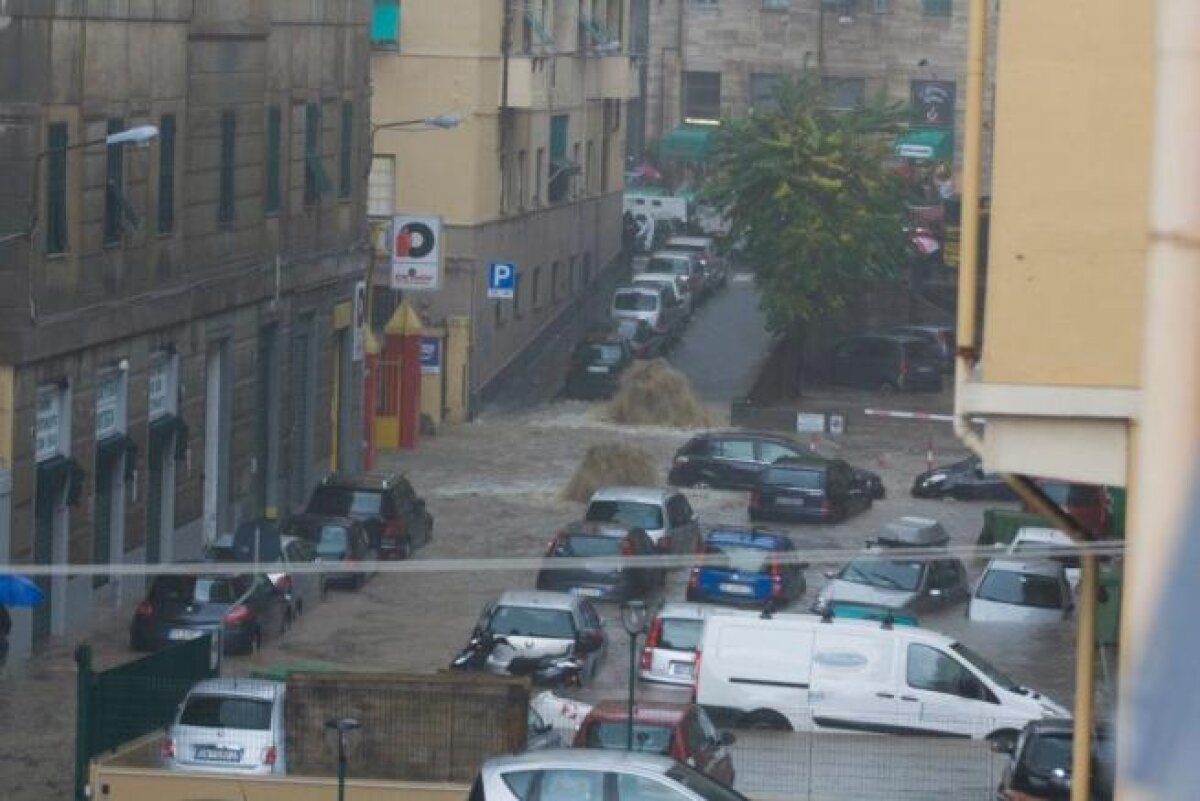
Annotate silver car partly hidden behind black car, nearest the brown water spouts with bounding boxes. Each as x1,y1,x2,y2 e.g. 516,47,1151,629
584,487,701,554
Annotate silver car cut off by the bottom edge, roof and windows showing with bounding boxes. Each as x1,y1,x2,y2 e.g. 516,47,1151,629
467,748,746,801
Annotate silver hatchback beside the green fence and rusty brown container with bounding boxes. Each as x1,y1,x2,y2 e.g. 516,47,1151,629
160,679,288,775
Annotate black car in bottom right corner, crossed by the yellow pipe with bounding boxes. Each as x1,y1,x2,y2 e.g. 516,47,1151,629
994,718,1116,801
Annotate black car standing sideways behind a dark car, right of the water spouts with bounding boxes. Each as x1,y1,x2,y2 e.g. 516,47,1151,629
667,430,886,500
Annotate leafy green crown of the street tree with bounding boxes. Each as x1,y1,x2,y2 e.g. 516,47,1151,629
702,73,906,331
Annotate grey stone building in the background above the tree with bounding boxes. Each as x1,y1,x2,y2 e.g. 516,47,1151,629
644,0,967,163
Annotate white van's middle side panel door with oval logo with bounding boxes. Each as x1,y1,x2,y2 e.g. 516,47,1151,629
809,627,899,734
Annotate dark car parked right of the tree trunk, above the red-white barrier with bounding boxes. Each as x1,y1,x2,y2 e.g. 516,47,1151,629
824,333,942,392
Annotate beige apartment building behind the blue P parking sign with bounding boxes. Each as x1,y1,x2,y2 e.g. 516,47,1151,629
370,0,637,408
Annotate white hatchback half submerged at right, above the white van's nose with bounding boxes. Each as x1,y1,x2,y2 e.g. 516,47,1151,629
967,559,1075,624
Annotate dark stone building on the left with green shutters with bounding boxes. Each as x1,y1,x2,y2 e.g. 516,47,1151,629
0,0,371,654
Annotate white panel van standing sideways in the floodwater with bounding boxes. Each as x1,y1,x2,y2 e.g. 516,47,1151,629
696,612,1070,739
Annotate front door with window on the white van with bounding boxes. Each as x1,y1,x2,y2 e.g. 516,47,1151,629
899,642,1001,737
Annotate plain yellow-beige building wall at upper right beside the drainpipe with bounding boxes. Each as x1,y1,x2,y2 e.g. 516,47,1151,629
982,0,1154,387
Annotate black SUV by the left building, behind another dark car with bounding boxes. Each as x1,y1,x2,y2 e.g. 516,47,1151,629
305,472,433,559
